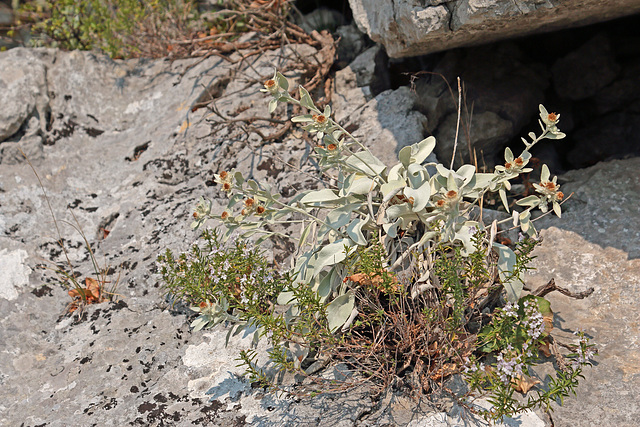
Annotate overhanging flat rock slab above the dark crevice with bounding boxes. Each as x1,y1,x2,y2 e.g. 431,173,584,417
349,0,640,58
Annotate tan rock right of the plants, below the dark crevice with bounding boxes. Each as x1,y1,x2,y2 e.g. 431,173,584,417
526,158,640,427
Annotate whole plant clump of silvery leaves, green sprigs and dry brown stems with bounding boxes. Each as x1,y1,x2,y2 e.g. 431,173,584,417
161,72,588,418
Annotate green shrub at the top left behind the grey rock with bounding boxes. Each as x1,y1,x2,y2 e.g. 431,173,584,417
14,0,197,58
